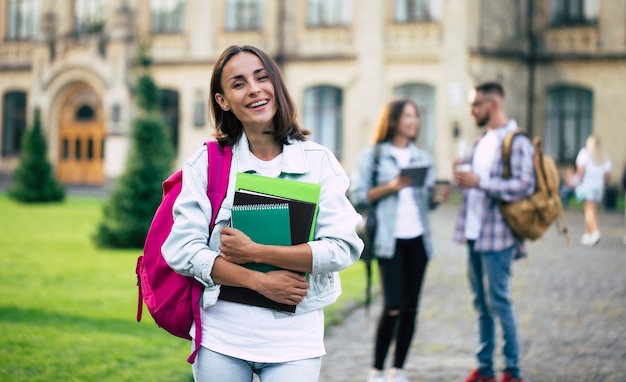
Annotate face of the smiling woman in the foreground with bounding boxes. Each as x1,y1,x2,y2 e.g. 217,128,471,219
215,52,277,131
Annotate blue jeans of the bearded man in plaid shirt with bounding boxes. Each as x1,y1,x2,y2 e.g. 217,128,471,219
467,240,521,378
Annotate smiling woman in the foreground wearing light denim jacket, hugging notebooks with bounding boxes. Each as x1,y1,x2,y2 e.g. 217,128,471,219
163,46,363,382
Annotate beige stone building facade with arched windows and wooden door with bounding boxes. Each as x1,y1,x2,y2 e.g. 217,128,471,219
0,0,626,185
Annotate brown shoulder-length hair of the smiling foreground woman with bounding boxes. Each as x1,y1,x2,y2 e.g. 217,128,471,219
210,45,310,146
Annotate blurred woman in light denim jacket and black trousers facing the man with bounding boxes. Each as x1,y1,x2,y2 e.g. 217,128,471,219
350,99,448,382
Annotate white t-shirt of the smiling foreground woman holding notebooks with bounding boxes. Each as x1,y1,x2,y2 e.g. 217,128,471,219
200,149,326,363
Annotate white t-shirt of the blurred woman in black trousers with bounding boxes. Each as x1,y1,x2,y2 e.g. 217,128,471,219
391,146,424,239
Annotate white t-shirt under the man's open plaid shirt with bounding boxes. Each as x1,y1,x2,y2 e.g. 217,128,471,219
465,130,500,240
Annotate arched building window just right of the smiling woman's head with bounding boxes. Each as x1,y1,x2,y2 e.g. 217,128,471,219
303,86,343,159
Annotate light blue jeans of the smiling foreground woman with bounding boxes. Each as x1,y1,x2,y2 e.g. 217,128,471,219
192,347,322,382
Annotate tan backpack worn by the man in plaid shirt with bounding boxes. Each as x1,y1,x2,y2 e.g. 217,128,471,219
499,130,570,246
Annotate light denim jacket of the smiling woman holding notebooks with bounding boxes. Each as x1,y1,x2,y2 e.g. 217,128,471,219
162,134,363,317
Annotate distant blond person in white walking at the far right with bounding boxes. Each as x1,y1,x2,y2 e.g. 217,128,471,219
576,135,611,246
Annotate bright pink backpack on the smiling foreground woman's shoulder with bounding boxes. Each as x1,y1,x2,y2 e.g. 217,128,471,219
135,141,232,363
